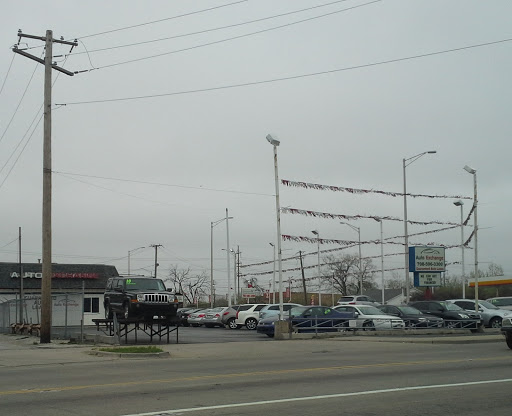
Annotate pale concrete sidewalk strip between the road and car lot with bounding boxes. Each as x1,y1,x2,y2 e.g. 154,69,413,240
0,331,505,369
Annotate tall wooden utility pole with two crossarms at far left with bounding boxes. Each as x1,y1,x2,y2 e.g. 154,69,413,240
12,30,78,344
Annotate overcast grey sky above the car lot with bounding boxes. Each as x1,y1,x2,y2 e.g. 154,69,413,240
0,0,512,300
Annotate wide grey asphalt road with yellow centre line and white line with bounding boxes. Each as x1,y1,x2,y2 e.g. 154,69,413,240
0,333,512,416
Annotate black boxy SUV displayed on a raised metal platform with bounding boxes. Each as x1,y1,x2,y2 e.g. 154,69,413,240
103,277,183,320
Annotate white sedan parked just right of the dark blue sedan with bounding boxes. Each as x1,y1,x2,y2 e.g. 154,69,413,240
334,305,405,330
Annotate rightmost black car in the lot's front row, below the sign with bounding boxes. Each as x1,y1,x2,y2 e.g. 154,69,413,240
409,300,482,332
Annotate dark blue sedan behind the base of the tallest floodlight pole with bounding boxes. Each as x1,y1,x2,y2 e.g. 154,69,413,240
256,306,354,337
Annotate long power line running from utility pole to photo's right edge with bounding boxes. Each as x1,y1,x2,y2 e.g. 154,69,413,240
56,38,512,106
